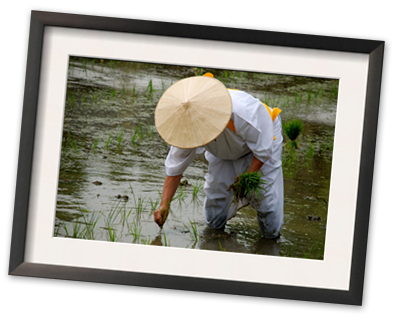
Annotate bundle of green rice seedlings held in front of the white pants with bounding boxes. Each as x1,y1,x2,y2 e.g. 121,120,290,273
228,170,267,204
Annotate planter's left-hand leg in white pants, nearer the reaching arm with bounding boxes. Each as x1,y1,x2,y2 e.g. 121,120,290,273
204,151,245,229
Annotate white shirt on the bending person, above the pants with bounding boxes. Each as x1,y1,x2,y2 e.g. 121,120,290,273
165,90,278,176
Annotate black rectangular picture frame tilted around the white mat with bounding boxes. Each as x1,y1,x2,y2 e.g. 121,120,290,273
9,12,383,305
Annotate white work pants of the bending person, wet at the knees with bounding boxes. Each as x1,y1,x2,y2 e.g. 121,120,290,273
204,117,283,238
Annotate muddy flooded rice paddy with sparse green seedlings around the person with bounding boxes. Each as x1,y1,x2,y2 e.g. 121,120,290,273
54,58,338,259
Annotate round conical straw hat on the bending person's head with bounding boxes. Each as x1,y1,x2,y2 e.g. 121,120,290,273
155,76,232,149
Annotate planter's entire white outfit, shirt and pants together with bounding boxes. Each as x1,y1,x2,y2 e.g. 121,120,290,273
165,90,283,238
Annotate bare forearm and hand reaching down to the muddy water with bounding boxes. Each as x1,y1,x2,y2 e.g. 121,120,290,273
154,175,182,227
